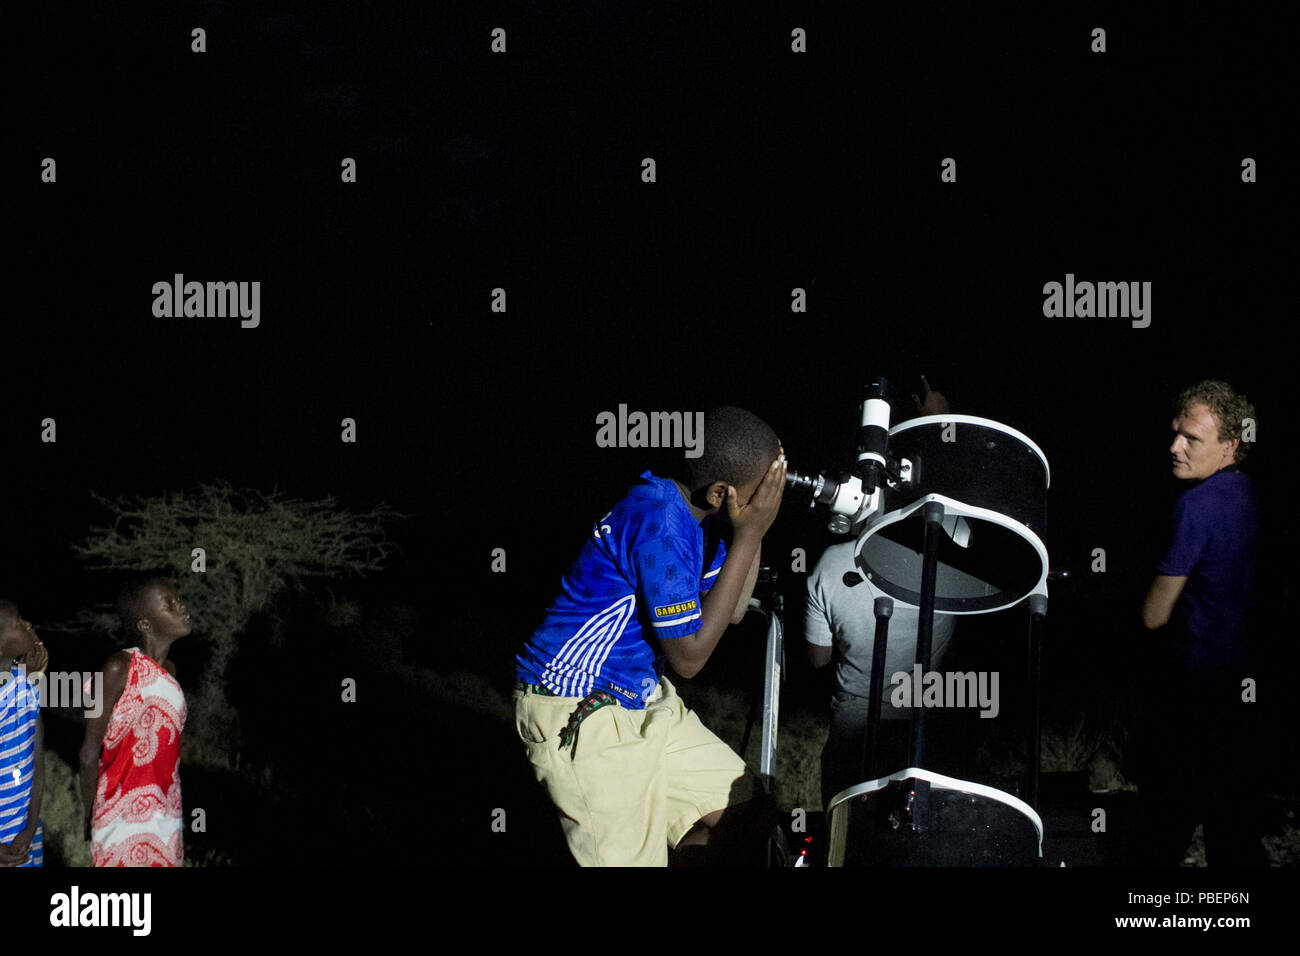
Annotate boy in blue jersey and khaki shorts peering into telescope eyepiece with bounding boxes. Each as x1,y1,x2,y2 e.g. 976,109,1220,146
515,408,785,866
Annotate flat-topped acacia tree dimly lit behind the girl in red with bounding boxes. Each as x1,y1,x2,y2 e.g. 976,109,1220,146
65,481,407,767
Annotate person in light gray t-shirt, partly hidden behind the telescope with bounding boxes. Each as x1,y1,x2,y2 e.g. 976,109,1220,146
805,541,954,806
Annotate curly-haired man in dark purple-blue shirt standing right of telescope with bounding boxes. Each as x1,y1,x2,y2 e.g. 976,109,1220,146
1139,381,1266,866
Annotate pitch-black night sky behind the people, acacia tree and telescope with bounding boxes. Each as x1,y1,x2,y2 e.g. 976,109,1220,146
0,3,1296,905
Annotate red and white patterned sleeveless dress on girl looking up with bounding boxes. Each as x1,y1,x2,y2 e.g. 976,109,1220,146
91,648,186,866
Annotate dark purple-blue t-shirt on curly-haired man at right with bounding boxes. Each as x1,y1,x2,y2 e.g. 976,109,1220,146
1157,467,1260,669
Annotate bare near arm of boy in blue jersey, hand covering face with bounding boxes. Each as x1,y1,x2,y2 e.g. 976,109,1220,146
659,455,785,678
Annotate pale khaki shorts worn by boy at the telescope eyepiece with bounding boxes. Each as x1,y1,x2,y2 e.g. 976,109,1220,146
515,678,754,866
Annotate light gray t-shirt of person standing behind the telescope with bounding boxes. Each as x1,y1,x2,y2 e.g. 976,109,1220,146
805,541,954,719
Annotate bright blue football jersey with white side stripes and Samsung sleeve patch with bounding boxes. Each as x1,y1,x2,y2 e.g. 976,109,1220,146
516,471,727,710
